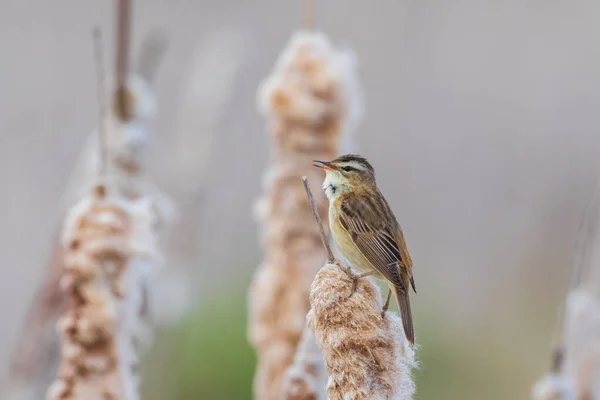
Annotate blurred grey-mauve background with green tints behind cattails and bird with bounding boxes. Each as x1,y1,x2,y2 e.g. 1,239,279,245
0,0,600,400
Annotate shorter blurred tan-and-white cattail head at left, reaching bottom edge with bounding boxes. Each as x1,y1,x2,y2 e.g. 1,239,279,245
47,185,157,400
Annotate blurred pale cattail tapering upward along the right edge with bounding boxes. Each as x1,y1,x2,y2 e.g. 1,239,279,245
533,181,600,400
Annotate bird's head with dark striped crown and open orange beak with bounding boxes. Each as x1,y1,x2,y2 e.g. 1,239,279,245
313,154,375,200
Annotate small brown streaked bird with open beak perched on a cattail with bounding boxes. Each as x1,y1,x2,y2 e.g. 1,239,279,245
313,154,417,345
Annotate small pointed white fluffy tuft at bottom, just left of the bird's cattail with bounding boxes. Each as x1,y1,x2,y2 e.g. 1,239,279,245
283,326,326,400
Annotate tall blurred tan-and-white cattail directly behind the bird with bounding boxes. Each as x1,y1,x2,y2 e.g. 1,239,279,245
249,28,360,400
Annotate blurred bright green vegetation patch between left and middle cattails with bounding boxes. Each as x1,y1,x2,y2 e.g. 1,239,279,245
142,291,256,400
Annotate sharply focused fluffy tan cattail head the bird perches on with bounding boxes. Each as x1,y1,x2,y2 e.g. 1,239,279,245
308,261,416,400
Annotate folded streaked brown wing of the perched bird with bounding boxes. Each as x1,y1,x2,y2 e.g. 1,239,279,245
340,196,406,290
